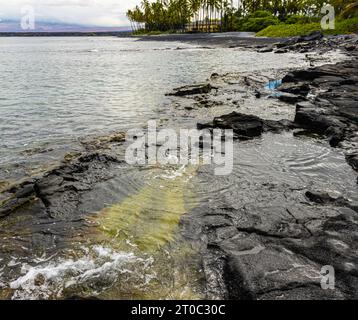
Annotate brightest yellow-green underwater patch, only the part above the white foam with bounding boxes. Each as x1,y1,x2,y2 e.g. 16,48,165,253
93,167,195,252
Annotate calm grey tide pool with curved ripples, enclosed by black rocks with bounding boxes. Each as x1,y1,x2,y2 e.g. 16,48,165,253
200,132,358,205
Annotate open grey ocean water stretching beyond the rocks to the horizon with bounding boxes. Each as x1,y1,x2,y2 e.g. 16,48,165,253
0,37,328,180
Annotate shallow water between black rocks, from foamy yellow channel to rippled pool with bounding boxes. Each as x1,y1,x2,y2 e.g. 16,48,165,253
0,132,358,299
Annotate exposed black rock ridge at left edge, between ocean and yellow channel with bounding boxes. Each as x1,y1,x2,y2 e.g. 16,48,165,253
0,153,119,217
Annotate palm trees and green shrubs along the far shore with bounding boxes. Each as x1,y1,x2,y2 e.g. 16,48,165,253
127,0,358,36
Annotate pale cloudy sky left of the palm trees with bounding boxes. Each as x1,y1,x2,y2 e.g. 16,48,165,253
0,0,139,27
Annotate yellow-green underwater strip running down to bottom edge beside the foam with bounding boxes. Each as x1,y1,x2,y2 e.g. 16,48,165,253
89,167,205,300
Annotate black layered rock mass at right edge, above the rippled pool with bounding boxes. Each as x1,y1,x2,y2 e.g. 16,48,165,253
282,57,358,171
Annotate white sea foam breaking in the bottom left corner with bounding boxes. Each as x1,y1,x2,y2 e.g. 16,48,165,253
9,246,153,299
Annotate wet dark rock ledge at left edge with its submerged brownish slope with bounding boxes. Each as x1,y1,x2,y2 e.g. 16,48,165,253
0,152,120,262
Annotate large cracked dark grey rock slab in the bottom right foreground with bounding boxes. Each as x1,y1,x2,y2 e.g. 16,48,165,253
186,190,358,300
